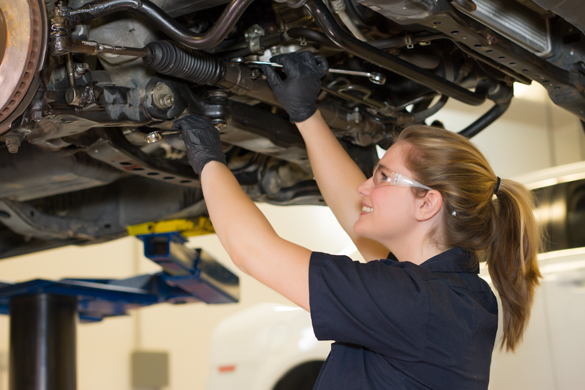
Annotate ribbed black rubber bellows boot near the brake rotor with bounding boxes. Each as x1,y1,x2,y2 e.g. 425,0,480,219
143,41,225,85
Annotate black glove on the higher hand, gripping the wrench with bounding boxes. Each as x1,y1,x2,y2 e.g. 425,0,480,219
263,51,329,123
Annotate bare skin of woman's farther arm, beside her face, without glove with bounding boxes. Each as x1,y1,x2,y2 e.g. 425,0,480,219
297,111,388,260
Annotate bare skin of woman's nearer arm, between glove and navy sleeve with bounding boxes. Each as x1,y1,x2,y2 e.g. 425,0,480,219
201,161,311,311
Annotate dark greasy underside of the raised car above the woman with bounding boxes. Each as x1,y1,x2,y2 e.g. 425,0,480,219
0,0,585,258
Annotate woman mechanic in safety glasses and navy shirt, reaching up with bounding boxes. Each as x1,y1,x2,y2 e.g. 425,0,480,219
175,52,540,390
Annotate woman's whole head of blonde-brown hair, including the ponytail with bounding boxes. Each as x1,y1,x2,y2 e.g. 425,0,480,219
395,125,542,351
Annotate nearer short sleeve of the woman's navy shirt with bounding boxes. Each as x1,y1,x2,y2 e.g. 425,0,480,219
309,252,429,361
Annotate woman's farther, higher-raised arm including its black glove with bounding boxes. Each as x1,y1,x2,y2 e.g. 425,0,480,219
263,52,388,260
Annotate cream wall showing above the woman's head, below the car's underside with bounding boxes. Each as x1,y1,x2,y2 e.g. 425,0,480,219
429,84,585,178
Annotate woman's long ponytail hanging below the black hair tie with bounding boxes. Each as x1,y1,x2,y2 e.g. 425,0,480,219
487,180,541,351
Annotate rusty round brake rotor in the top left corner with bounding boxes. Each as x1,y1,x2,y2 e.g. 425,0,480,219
0,0,45,122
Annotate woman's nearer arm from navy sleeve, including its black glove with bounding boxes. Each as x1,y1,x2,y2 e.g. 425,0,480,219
173,115,311,310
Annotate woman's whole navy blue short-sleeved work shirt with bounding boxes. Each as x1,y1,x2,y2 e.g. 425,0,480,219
309,248,498,390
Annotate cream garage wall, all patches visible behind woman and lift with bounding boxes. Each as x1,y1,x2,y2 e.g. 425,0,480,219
0,86,585,390
